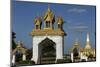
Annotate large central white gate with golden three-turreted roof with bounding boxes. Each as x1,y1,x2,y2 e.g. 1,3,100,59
31,7,65,64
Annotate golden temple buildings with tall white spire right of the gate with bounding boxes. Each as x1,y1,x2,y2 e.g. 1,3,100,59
70,33,96,62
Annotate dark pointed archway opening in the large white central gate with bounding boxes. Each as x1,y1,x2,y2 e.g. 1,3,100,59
38,38,56,64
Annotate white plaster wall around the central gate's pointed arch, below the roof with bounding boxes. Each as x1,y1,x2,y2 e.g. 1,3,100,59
32,35,63,63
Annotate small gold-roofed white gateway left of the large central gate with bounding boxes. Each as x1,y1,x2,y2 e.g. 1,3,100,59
12,41,27,64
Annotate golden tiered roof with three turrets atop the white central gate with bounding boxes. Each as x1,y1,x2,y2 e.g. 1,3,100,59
30,7,65,36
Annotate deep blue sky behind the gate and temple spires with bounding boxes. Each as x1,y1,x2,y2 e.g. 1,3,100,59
11,1,96,54
